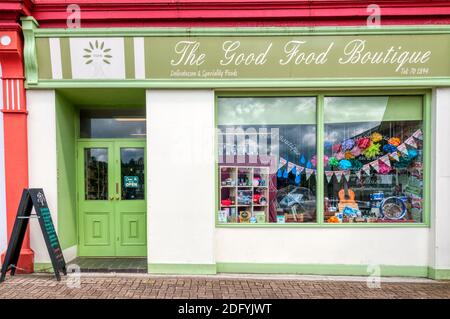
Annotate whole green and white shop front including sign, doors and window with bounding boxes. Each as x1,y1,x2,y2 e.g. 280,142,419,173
22,17,450,278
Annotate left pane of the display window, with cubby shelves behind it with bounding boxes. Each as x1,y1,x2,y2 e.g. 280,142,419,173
217,97,317,224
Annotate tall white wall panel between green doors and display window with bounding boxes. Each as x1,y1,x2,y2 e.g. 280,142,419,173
147,90,215,264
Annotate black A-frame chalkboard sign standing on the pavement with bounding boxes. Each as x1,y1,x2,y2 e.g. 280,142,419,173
0,188,67,282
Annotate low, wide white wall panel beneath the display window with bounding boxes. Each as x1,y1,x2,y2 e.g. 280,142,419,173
216,228,428,266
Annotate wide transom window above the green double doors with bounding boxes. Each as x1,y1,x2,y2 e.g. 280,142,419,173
80,109,146,138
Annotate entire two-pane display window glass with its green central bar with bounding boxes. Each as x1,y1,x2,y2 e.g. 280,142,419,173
217,94,427,226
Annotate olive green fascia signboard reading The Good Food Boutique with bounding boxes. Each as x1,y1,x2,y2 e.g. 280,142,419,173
36,34,450,80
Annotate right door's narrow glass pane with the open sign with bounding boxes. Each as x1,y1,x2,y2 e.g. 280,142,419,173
120,147,145,200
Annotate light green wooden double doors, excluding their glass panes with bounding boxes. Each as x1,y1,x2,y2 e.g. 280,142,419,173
77,138,147,257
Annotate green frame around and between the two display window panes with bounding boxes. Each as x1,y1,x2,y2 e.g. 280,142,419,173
214,89,432,228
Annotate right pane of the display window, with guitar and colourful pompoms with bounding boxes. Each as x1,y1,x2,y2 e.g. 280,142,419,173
324,96,424,223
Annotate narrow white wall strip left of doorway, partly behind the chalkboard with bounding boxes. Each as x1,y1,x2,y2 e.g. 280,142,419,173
27,90,58,263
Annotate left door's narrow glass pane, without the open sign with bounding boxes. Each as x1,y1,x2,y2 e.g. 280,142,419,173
84,148,108,200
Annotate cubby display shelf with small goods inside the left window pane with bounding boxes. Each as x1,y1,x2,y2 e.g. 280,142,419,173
219,166,270,223
